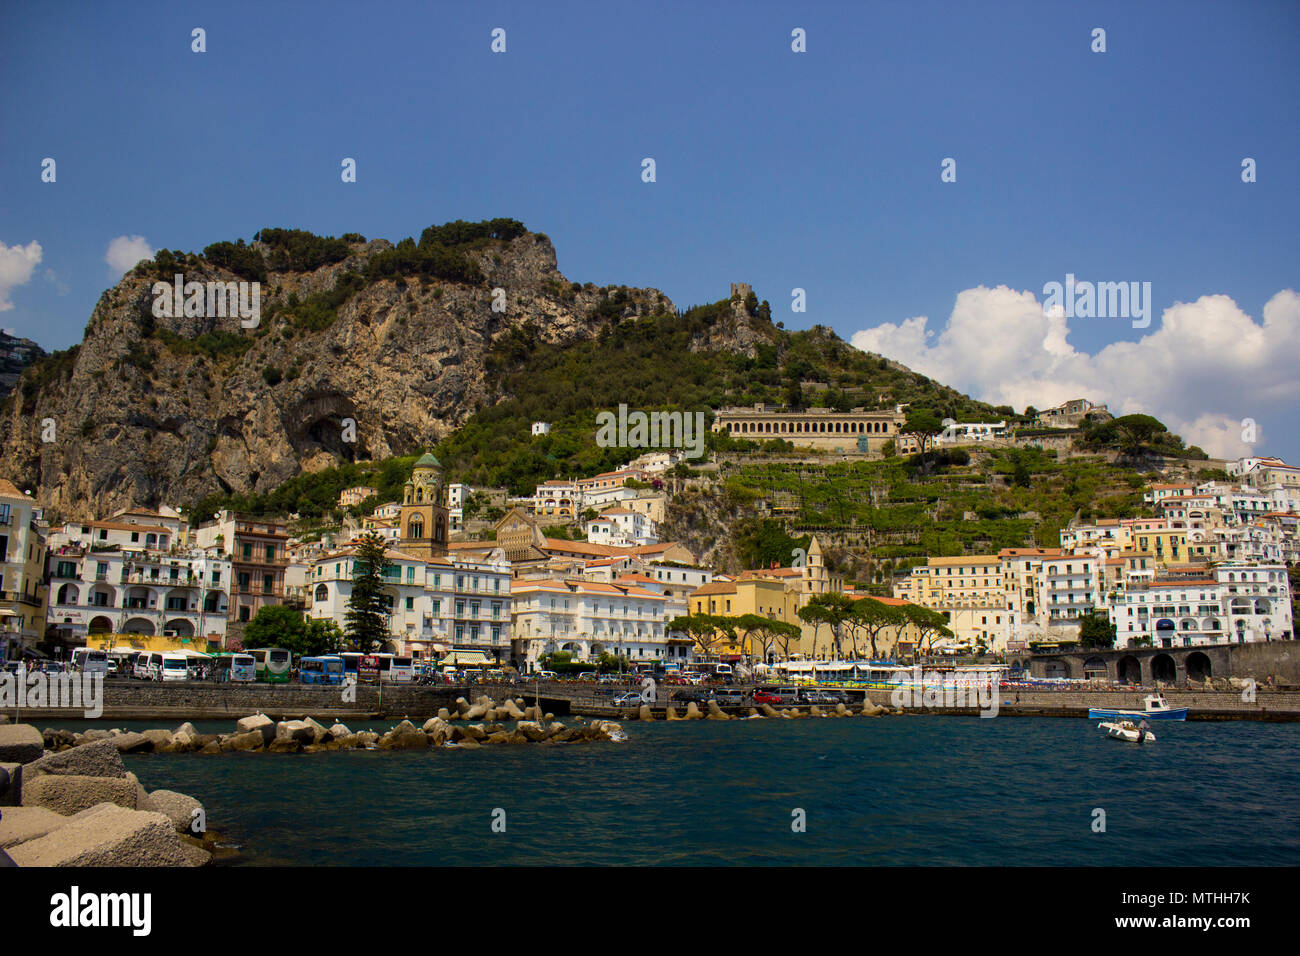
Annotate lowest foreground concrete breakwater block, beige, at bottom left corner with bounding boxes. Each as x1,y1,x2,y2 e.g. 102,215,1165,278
8,806,208,866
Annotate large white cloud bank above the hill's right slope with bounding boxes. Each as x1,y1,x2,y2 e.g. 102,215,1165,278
852,286,1300,457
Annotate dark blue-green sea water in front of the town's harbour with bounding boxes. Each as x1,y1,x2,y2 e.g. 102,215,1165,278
40,717,1300,866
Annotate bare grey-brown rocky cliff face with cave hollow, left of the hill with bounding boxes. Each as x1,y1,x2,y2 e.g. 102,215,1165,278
0,232,681,519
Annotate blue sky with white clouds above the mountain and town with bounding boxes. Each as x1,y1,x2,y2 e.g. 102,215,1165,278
0,0,1300,459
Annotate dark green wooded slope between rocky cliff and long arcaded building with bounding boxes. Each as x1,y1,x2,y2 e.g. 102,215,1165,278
436,300,995,494
